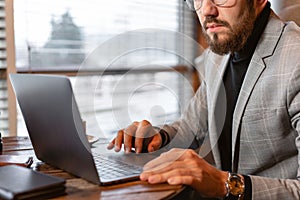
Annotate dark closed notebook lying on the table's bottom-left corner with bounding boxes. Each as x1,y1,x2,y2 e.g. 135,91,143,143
0,165,65,199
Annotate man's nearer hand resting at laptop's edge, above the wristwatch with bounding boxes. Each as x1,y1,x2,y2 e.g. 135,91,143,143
140,149,228,198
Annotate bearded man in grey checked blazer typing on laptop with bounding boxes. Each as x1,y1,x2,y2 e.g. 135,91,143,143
108,0,300,199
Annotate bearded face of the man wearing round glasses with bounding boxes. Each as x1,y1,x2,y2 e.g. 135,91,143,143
197,0,256,55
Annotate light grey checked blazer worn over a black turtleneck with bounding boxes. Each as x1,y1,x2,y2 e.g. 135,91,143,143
163,12,300,200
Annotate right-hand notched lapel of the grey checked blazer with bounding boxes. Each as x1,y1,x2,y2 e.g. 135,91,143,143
232,12,284,170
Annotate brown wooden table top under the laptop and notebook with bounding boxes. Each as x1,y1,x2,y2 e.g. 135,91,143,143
3,137,184,200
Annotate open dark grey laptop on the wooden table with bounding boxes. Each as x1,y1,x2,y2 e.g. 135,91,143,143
9,74,153,185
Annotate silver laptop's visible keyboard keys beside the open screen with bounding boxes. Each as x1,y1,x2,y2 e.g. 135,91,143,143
93,154,142,179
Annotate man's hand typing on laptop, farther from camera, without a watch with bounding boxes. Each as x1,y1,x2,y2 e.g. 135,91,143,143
107,120,162,153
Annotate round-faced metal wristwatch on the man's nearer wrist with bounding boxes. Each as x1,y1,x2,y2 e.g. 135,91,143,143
225,172,245,200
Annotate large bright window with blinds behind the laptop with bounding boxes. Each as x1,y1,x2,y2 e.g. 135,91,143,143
14,0,199,138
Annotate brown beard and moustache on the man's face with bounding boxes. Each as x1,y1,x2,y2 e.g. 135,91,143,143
202,5,255,55
